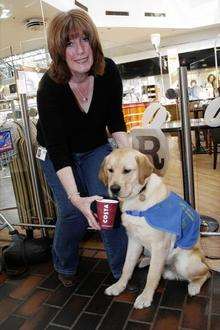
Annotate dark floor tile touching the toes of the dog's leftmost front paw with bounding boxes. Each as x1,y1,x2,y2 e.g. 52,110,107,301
86,286,113,314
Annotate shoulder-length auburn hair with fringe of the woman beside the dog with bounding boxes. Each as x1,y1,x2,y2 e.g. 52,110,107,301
48,9,105,84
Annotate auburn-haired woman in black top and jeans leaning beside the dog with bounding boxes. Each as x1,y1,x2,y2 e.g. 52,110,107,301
37,10,128,286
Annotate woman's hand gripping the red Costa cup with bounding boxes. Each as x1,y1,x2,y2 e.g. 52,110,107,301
70,195,103,230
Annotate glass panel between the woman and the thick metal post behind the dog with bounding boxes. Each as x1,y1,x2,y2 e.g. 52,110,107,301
119,52,183,195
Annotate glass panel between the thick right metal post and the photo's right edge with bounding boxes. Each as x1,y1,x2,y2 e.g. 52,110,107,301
188,66,220,229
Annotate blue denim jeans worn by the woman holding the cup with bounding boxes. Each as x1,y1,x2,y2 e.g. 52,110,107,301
40,143,127,279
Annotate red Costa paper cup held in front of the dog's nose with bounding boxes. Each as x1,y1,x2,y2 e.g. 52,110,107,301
96,199,118,229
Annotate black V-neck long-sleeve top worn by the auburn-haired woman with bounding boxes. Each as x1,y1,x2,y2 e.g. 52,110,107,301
37,58,126,171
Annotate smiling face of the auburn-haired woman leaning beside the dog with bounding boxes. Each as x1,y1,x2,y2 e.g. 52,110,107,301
65,33,93,75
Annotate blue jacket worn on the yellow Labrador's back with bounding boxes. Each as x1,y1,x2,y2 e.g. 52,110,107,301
126,192,200,249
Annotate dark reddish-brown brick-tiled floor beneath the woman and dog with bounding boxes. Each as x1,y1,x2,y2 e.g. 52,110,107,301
0,241,220,330
